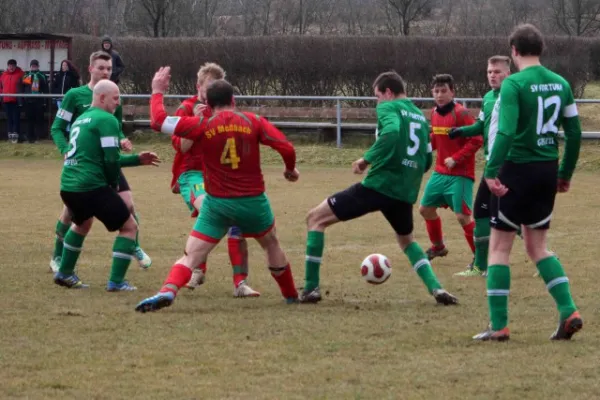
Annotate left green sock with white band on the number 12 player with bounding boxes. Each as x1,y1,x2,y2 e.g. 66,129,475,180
487,264,510,331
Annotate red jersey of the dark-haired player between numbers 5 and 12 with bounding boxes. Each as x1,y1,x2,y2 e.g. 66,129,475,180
431,102,483,180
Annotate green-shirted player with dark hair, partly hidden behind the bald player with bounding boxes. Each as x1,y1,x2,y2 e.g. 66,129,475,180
50,51,152,272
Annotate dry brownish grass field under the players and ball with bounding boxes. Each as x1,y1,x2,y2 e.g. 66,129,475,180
0,142,600,399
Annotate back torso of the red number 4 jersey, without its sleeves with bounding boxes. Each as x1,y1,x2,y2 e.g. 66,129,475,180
201,111,265,197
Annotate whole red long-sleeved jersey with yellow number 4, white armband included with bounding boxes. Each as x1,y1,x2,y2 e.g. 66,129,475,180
150,94,296,198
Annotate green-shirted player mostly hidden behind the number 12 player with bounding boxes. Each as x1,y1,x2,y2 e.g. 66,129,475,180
448,55,510,276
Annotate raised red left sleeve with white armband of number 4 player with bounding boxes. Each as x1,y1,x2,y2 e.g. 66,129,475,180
150,93,208,141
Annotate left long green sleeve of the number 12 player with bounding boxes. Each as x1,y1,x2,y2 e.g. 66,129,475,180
484,79,519,179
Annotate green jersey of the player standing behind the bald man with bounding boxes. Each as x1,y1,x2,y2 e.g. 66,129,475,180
50,85,125,154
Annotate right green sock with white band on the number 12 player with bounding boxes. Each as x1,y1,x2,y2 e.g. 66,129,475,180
537,256,577,320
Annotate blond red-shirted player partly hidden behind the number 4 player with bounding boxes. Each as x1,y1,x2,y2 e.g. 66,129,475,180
171,63,260,297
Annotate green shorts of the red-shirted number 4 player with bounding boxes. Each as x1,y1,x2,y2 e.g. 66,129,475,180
191,193,275,243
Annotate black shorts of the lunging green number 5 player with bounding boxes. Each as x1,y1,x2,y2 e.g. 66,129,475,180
327,183,413,236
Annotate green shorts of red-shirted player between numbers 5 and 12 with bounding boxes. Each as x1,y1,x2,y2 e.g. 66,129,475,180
421,172,473,215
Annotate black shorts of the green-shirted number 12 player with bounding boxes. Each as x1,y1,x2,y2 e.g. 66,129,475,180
490,161,558,232
